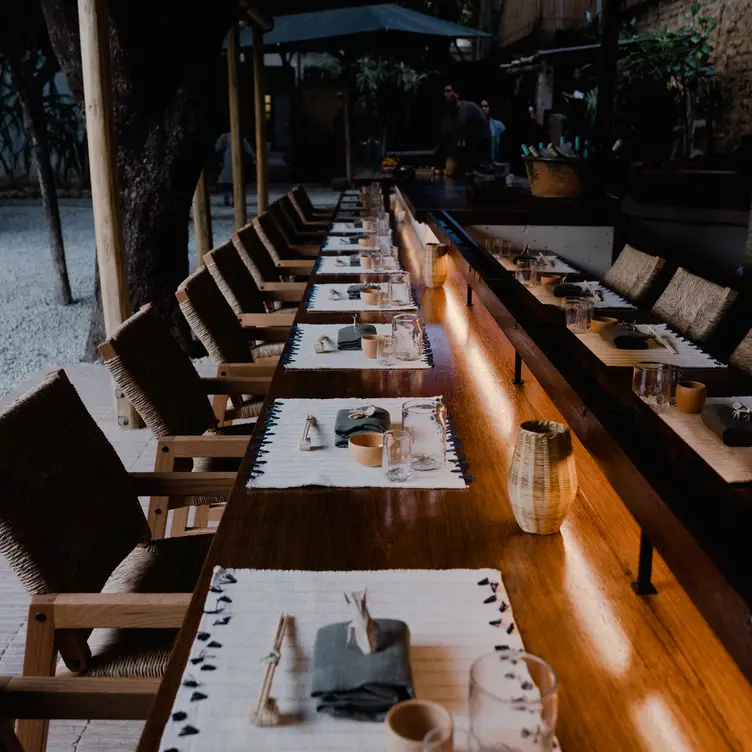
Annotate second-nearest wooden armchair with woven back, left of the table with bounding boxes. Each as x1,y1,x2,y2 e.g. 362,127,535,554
99,305,273,539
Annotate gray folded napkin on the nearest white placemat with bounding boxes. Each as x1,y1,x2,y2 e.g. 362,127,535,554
311,619,415,722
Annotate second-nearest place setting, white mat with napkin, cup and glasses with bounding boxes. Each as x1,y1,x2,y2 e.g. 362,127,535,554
246,396,472,490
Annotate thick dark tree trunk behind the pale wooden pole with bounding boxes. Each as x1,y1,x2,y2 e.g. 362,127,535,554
42,0,236,350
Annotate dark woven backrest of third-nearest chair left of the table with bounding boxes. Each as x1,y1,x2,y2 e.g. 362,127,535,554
175,267,253,363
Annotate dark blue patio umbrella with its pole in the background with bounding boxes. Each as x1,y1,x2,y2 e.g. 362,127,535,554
235,4,492,182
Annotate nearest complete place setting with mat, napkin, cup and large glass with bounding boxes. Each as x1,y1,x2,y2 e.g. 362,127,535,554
159,567,559,752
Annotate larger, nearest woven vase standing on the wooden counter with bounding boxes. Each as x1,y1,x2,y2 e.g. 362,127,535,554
509,420,577,535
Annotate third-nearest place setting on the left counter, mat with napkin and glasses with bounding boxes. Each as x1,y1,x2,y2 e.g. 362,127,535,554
282,313,433,371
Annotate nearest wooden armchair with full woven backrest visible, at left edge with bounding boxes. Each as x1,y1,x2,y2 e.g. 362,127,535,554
0,371,232,752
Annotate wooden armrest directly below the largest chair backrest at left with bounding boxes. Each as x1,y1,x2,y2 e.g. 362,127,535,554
29,593,193,629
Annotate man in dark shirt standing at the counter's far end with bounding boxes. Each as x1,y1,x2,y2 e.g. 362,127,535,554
439,84,491,177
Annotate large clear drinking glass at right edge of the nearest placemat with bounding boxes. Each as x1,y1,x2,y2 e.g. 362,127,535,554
467,650,558,752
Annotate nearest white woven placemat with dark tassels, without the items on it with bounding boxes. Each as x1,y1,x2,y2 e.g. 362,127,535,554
159,567,540,752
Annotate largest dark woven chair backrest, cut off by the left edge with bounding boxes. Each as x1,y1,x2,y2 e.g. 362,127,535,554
0,371,150,670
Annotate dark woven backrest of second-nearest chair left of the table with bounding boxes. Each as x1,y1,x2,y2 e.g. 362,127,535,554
99,304,217,437
